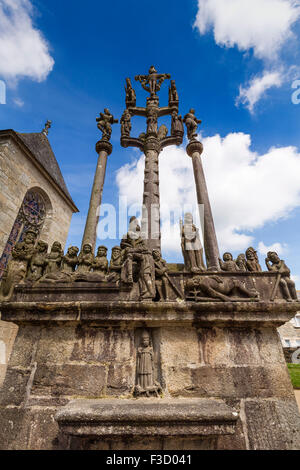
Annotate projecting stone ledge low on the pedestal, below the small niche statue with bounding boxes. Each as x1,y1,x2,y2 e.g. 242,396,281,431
55,399,238,438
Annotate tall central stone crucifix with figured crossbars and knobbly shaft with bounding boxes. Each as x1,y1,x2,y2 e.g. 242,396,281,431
121,65,184,251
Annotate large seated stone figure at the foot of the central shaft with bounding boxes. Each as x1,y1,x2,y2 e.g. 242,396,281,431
121,217,156,301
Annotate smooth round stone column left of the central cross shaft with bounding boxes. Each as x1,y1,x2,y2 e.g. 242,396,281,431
82,140,112,251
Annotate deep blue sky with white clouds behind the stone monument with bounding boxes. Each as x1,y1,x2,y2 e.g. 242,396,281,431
0,0,300,288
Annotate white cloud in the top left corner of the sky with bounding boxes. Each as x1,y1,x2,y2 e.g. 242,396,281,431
0,0,54,85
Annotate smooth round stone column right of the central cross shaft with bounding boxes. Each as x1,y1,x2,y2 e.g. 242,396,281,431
186,140,220,271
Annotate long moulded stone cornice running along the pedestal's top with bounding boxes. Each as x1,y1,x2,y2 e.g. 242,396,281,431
0,301,300,328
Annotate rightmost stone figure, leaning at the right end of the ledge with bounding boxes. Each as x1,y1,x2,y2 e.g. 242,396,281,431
266,251,297,302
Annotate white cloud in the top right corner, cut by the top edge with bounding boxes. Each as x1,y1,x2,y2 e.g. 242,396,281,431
195,0,300,60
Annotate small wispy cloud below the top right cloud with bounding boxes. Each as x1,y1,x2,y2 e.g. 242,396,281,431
236,71,284,114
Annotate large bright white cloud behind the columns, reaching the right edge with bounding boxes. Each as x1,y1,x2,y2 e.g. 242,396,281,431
117,133,300,254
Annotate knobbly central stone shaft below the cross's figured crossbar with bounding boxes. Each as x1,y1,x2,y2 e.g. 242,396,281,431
142,137,161,251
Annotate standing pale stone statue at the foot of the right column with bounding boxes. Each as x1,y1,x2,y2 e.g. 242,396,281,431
181,213,206,274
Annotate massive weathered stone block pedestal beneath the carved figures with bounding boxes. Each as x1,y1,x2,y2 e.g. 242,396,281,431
0,286,300,449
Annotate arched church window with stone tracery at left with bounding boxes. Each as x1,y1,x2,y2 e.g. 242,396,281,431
0,189,46,279
